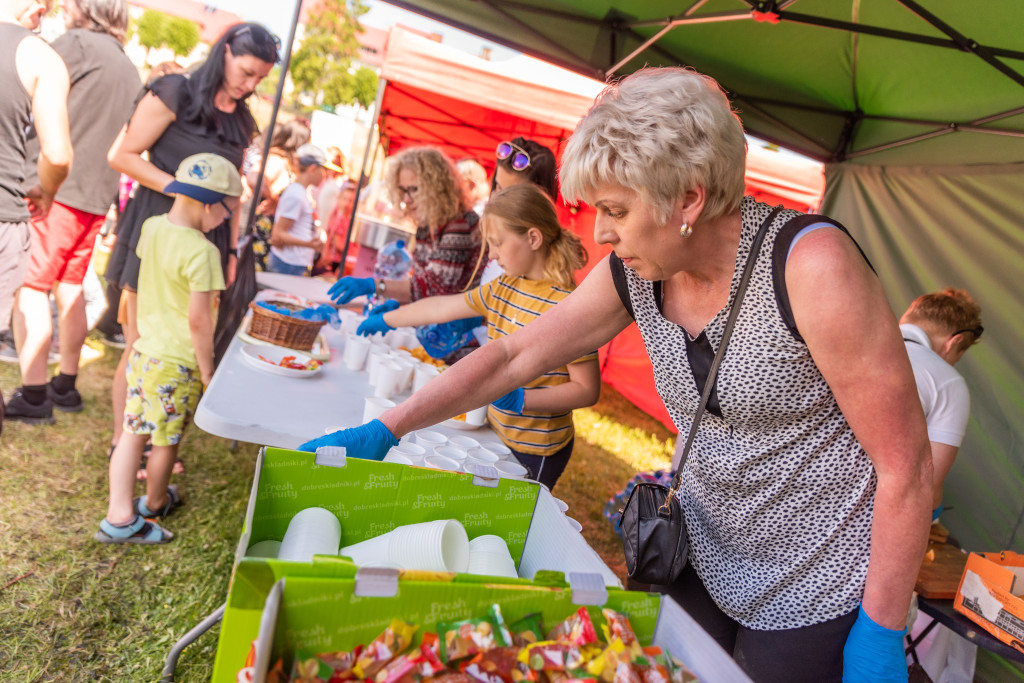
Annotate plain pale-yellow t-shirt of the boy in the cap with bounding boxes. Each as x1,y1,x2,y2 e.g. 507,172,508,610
134,214,224,370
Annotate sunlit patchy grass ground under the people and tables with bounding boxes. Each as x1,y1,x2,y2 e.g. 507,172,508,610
0,339,674,683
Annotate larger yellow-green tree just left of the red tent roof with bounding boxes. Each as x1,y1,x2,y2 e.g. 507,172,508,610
290,0,377,106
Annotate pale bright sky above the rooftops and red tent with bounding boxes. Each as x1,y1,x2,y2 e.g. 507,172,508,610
205,0,515,59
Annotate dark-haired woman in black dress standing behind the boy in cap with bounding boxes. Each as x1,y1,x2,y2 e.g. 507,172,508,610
106,24,281,458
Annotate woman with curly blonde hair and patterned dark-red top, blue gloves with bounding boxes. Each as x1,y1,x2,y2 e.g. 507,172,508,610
330,147,481,304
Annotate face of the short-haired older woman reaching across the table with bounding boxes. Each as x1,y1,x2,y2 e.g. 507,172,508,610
592,183,683,281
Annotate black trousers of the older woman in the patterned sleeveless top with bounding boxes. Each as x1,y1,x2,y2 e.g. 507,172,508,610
651,565,857,683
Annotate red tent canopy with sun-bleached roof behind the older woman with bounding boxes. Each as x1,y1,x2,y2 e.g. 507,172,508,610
377,27,824,429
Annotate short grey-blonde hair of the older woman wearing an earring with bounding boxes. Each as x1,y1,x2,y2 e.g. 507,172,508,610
559,67,746,220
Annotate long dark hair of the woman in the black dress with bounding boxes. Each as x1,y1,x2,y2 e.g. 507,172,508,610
184,24,281,139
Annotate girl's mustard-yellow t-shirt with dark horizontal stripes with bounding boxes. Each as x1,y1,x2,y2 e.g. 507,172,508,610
464,275,597,456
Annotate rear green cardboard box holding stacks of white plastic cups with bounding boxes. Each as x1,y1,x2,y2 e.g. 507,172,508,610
214,447,622,681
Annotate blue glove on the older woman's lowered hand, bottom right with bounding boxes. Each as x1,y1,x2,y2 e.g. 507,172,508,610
843,606,907,683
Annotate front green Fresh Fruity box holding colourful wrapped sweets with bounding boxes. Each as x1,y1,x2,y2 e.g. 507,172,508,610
224,568,750,683
